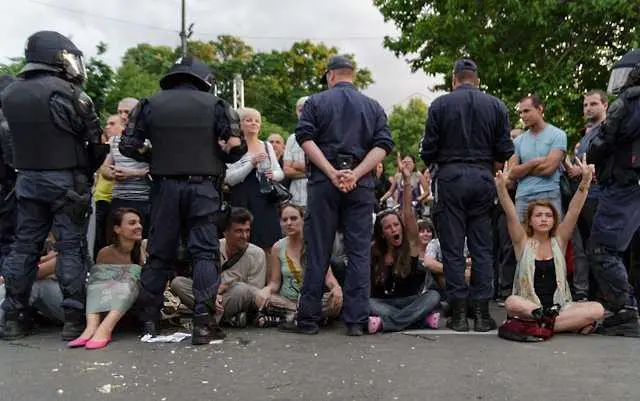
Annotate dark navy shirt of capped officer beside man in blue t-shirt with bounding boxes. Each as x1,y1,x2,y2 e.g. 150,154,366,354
420,84,514,168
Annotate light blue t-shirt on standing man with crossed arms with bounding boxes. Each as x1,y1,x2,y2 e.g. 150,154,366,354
514,123,567,199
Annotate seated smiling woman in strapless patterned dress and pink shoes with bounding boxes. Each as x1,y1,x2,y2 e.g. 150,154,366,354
69,208,144,349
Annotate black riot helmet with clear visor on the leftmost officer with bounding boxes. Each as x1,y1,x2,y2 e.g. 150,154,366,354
18,31,87,84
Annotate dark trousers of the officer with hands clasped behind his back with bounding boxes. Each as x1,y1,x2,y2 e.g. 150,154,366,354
297,181,374,329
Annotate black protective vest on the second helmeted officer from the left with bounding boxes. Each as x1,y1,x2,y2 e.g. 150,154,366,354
148,89,224,176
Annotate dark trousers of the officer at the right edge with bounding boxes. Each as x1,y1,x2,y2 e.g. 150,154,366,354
587,185,640,312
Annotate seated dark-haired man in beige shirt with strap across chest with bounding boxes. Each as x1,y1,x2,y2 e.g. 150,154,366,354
171,207,267,327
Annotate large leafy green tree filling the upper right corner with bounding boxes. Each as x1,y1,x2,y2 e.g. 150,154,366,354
374,0,640,139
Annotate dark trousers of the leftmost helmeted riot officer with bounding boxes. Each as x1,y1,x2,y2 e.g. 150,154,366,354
2,170,90,314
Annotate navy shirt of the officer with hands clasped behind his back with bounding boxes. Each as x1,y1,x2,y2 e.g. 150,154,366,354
295,82,393,188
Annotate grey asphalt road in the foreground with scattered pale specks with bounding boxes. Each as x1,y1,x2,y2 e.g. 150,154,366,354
0,316,640,401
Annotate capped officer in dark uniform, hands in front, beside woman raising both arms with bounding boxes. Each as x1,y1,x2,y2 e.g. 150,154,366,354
420,59,514,331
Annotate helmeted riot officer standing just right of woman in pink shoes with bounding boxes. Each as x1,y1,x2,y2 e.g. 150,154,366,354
120,57,246,345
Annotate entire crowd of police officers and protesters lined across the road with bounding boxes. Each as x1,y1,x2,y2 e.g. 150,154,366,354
0,31,640,349
